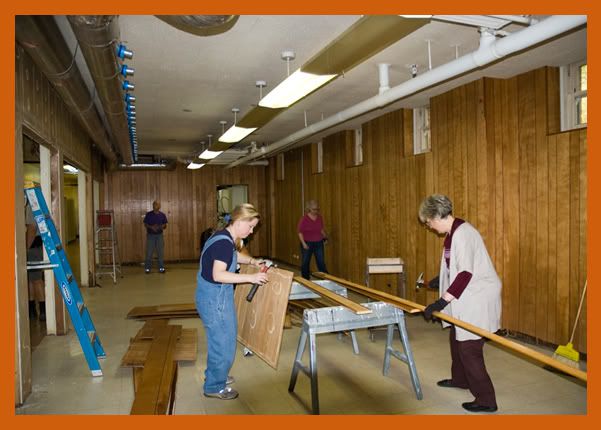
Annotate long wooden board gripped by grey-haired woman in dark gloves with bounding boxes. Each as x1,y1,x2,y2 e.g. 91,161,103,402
313,272,587,381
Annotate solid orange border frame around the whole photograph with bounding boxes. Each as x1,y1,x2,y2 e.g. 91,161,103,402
0,0,601,430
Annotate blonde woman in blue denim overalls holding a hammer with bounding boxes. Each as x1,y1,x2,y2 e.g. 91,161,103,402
195,203,267,400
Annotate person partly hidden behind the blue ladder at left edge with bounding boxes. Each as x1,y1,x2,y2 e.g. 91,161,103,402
25,197,46,321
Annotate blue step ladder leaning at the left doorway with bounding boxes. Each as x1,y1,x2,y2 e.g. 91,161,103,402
25,187,106,376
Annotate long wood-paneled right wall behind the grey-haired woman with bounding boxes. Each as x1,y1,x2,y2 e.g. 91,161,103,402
270,68,587,351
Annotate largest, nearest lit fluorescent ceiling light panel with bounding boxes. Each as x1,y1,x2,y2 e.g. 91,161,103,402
259,69,337,109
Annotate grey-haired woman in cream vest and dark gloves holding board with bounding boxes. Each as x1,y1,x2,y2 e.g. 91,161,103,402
419,194,501,412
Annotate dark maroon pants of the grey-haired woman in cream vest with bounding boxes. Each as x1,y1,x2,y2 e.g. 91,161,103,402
449,326,497,407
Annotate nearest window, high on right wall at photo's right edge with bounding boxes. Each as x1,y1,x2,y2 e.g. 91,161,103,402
560,61,588,131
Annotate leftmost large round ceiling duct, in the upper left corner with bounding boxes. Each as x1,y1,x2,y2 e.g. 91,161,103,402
15,15,117,164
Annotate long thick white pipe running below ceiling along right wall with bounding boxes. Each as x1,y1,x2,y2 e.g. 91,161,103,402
226,15,586,168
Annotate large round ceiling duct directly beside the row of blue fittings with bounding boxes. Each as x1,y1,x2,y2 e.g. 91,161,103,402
67,15,134,164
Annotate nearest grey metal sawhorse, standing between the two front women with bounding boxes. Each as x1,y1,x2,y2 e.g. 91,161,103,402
288,302,423,414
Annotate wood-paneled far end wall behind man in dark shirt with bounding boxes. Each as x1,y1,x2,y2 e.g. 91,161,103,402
104,165,269,263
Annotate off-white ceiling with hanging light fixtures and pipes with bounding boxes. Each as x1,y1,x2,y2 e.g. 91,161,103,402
58,15,586,164
